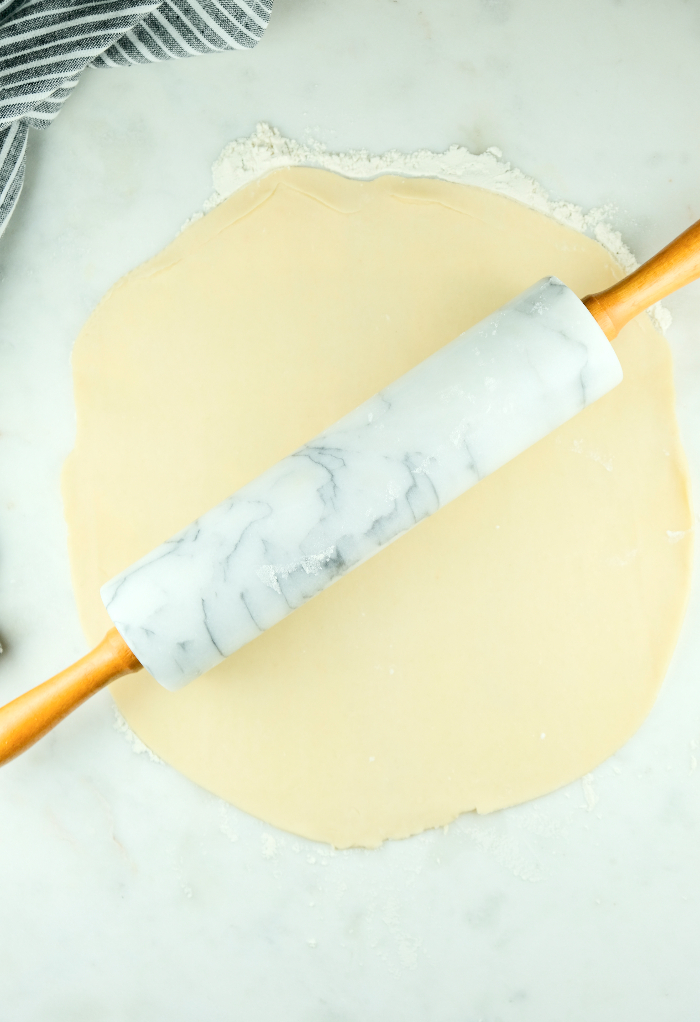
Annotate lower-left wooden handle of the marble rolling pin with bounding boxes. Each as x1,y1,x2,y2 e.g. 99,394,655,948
0,629,141,765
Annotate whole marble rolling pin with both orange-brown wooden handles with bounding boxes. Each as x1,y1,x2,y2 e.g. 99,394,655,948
0,215,700,763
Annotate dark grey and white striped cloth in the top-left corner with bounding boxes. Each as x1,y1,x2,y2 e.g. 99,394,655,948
0,0,273,234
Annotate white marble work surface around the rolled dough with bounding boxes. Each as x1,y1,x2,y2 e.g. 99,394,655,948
0,0,700,1022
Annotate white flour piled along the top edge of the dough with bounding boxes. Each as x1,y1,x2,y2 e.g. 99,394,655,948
183,124,671,333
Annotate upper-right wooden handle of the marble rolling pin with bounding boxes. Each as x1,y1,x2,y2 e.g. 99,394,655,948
584,220,700,340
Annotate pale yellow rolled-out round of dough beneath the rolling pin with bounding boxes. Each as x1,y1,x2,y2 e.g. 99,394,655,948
64,169,692,847
